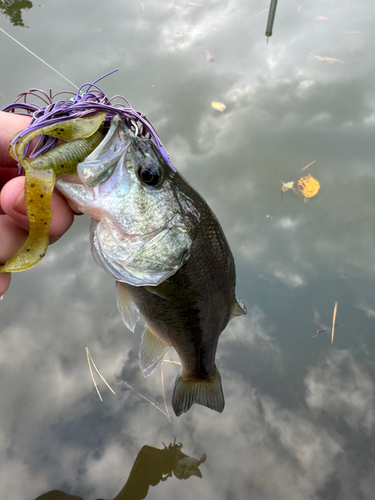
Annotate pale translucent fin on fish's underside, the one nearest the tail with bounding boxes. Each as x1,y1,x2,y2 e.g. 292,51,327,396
139,325,170,377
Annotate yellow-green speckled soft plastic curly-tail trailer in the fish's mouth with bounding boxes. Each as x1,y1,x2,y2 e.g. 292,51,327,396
0,113,106,273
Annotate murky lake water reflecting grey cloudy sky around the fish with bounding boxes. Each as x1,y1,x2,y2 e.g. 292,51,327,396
0,0,375,500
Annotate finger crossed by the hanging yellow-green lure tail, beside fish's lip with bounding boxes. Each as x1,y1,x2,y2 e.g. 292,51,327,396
0,177,74,243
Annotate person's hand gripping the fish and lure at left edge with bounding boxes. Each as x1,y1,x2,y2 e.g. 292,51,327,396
0,111,74,296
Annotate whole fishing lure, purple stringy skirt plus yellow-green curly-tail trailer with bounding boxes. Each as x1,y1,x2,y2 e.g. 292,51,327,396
0,70,176,273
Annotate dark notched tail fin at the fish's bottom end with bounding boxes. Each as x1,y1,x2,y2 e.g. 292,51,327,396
172,367,225,417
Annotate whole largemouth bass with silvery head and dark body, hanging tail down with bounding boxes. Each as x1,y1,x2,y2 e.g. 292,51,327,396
56,116,246,416
